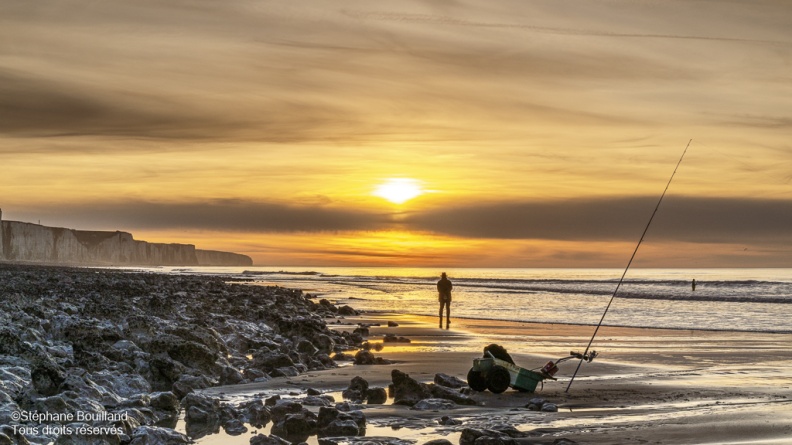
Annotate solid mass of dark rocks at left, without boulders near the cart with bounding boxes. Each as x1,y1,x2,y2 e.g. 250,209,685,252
0,264,362,445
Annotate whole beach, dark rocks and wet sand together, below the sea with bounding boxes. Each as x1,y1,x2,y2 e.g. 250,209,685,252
0,264,792,445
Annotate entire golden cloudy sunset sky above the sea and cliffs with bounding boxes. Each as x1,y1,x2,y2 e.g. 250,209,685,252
0,0,792,268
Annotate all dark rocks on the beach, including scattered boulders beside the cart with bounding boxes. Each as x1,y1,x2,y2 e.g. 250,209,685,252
0,264,580,445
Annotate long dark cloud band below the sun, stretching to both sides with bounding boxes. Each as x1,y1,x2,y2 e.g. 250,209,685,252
12,196,792,244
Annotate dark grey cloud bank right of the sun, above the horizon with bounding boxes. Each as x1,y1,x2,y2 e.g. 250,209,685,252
404,197,792,243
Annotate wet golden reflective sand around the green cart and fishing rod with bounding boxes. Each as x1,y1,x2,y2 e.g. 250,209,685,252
203,314,792,444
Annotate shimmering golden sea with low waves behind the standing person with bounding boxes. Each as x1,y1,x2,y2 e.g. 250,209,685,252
144,267,792,333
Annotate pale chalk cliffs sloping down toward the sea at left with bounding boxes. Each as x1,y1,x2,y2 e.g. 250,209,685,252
0,221,253,266
